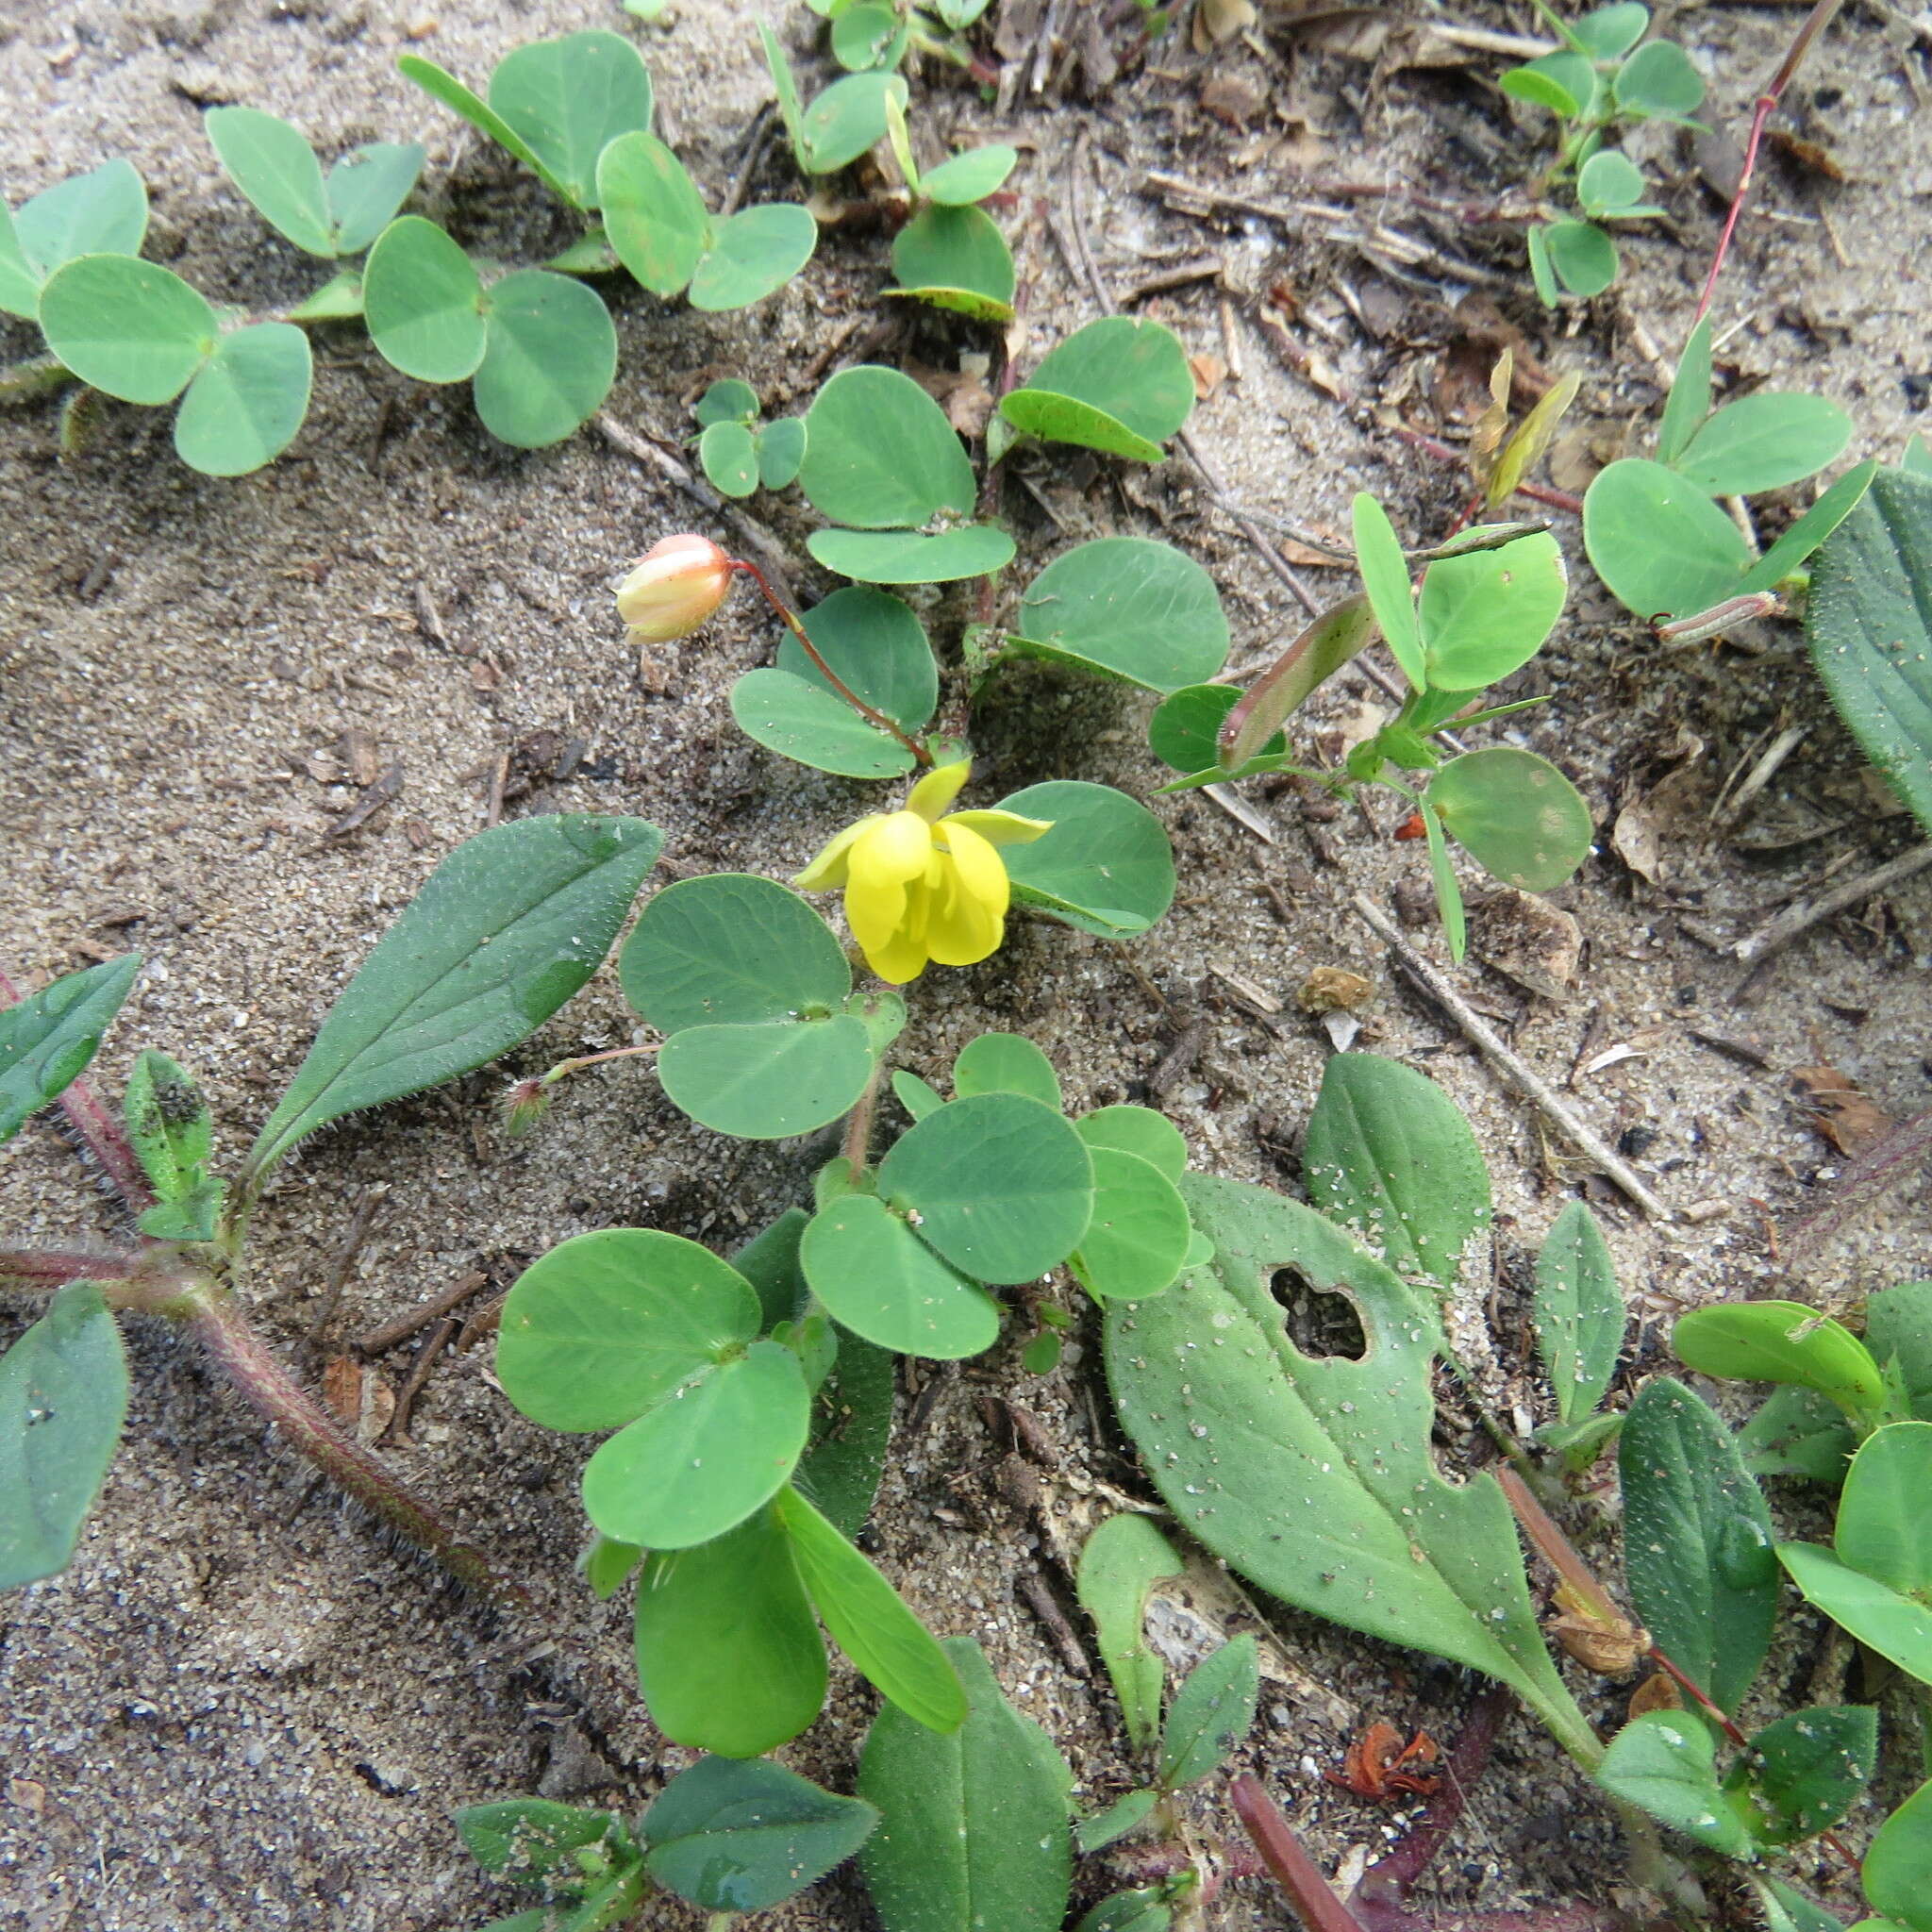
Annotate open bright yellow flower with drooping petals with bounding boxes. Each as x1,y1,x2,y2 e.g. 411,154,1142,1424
792,759,1053,985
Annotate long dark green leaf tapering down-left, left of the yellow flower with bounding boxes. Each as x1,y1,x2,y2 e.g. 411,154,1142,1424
247,813,665,1180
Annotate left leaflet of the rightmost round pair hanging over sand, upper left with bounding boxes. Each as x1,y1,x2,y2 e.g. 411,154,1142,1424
475,269,616,450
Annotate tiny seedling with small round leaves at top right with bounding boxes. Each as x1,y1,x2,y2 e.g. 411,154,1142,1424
1501,0,1704,309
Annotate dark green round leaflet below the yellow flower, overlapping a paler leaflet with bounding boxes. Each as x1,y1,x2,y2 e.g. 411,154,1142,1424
879,1093,1093,1283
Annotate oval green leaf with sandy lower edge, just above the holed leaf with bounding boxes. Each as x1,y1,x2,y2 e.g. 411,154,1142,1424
1302,1053,1491,1294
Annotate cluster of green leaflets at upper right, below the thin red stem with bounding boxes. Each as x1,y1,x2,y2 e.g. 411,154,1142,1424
1582,321,1878,622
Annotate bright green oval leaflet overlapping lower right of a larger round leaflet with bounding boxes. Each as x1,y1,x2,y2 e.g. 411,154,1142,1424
583,1341,811,1549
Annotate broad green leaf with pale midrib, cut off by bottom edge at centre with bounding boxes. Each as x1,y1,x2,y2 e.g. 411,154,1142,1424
858,1637,1073,1932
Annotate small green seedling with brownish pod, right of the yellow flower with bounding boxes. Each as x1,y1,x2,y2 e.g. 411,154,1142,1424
1148,494,1592,960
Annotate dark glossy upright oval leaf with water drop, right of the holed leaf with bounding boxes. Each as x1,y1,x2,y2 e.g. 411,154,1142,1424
1617,1375,1777,1712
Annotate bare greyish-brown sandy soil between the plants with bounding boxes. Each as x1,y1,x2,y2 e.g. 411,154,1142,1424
0,0,1932,1932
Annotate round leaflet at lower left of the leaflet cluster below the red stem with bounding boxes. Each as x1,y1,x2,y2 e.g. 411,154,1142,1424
1582,456,1753,618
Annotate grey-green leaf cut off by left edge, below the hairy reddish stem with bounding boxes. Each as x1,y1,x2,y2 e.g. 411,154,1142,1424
0,1282,127,1591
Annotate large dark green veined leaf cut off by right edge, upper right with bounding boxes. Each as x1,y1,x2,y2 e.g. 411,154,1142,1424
1805,470,1932,833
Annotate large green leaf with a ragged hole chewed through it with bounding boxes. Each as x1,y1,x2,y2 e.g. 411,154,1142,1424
1105,1174,1598,1762
